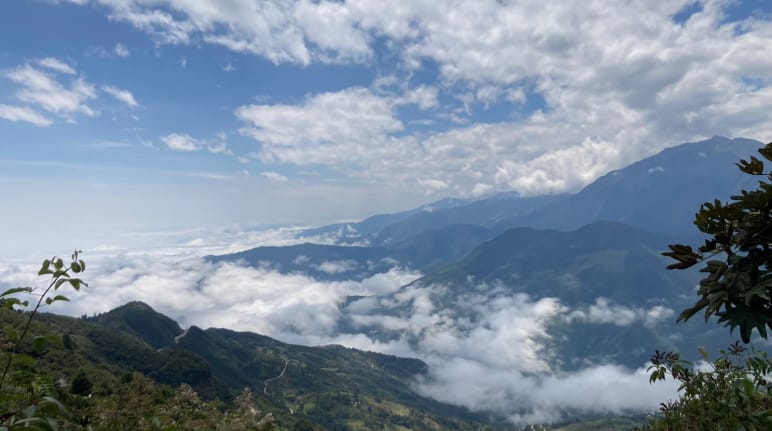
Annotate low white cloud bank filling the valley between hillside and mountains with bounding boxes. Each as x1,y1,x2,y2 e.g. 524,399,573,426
0,233,676,423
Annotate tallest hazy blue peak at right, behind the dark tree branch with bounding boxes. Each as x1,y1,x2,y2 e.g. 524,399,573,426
496,136,763,236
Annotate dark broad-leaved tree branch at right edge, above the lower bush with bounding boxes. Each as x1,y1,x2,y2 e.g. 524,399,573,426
663,143,772,343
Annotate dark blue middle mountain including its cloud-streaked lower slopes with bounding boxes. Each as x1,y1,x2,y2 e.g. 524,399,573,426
340,222,731,370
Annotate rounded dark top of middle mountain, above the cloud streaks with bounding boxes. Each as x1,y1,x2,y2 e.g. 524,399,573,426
416,222,690,304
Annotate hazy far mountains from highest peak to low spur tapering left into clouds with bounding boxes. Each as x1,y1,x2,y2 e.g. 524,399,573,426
216,137,762,280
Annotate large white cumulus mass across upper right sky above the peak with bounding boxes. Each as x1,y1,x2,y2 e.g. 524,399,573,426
63,0,772,195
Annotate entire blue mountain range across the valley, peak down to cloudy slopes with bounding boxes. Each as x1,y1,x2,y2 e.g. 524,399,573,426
202,137,762,422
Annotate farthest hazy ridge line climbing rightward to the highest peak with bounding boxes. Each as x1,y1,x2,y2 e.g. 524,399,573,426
296,136,763,247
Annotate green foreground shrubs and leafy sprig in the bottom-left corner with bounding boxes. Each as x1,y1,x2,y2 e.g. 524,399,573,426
0,251,274,431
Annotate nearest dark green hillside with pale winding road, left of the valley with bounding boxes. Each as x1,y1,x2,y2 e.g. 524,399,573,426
10,302,506,431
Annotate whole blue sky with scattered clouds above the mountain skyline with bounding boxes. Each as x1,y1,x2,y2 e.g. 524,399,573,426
0,0,772,253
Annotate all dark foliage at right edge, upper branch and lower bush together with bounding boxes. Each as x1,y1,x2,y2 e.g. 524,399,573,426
644,143,772,431
